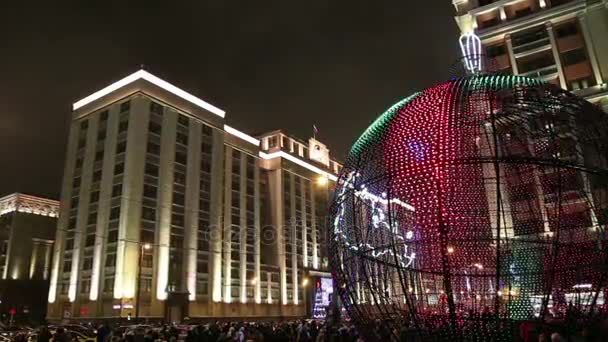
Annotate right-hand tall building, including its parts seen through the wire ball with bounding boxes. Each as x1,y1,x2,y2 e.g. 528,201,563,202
453,0,608,315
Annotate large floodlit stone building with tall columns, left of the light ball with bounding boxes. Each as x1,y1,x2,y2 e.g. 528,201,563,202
47,70,341,321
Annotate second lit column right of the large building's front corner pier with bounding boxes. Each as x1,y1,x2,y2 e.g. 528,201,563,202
184,120,202,301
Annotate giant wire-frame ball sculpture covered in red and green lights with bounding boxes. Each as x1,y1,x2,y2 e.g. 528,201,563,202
328,75,608,341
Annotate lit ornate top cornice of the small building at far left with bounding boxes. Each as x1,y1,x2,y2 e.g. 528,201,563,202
0,193,59,217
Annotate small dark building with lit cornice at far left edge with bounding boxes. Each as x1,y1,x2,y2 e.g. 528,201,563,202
0,193,59,321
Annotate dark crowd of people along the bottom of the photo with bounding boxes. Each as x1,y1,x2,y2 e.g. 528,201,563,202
13,319,608,342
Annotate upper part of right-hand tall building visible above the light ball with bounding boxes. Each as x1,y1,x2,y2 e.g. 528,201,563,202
452,0,608,111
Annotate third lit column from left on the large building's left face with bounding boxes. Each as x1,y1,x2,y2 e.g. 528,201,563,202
89,106,120,300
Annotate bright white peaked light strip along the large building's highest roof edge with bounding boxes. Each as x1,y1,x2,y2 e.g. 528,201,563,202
72,70,226,118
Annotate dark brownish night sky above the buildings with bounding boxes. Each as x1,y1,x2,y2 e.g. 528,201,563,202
0,0,459,198
